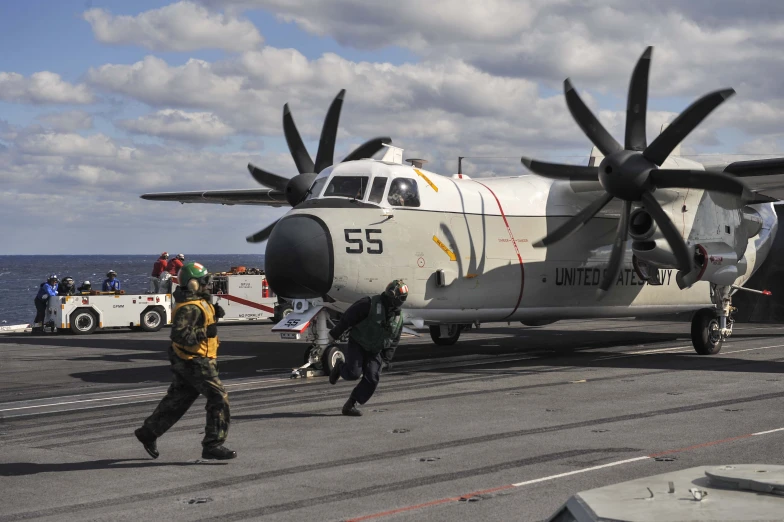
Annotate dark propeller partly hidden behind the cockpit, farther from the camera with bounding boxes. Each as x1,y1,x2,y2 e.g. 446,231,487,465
245,89,392,243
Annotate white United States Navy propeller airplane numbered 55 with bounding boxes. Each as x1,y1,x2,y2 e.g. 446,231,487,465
142,48,784,371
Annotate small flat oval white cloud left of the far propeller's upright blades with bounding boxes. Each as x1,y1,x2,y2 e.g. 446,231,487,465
118,109,234,144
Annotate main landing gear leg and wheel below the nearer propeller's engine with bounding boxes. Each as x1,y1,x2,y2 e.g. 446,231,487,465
691,284,738,355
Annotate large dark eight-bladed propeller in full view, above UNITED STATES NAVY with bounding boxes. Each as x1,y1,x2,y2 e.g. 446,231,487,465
522,47,752,299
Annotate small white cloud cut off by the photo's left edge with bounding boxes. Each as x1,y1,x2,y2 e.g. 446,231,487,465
0,71,95,104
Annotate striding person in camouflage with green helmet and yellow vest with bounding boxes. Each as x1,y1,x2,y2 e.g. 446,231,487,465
134,263,237,460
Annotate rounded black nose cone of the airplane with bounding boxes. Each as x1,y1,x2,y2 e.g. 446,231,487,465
264,215,334,299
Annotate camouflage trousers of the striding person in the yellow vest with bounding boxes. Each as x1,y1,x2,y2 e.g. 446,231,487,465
144,347,231,448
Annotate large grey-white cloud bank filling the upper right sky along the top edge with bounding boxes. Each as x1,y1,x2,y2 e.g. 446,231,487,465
202,0,784,101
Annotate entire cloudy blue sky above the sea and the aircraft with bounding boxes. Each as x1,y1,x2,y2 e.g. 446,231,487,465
0,0,784,254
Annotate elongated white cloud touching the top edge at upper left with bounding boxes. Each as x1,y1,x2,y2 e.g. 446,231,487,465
83,2,264,51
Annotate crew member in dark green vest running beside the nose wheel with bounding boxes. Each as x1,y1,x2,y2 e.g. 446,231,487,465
329,280,408,417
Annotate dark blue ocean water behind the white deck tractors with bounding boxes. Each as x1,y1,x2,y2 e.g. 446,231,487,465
0,253,264,325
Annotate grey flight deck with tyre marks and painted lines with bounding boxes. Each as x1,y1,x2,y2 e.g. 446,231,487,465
0,320,784,522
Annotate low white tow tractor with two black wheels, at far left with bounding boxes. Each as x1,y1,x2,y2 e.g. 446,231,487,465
44,292,171,335
